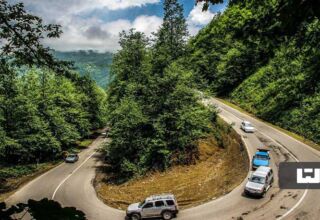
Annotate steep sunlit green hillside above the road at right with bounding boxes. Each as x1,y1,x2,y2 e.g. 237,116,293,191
231,19,320,143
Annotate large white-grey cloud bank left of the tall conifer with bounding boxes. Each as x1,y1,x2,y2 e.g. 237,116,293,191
9,0,162,52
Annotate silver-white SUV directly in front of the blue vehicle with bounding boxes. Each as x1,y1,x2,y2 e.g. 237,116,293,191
244,166,273,197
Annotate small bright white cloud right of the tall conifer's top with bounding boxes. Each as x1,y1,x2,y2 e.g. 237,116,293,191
187,3,215,35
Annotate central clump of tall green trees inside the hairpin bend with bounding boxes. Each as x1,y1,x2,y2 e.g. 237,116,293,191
106,0,216,177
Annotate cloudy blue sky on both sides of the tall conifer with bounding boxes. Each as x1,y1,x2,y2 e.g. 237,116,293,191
9,0,226,52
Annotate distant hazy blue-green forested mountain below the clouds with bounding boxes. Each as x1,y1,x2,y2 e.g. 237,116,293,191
53,50,113,89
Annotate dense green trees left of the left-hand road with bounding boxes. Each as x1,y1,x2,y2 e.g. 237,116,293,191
0,68,105,163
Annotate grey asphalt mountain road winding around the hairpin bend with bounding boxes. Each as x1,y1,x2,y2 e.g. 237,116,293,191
6,99,320,220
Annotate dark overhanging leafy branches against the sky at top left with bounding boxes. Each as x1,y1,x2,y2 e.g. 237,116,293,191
0,0,70,73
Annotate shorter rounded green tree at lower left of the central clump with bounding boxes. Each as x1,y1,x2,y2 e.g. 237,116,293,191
108,98,150,176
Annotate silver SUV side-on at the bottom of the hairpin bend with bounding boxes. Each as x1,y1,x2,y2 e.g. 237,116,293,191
127,194,179,220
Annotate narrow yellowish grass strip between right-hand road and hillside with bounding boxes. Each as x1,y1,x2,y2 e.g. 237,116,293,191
216,98,320,150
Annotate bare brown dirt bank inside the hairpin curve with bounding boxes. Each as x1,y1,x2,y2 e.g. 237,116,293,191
94,125,249,209
